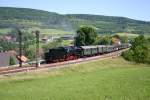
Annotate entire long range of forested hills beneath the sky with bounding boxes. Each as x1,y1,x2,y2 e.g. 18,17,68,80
0,7,150,34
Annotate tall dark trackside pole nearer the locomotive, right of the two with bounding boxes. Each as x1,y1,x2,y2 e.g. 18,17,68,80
35,31,40,68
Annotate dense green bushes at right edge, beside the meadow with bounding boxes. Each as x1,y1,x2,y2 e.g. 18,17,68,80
122,35,150,64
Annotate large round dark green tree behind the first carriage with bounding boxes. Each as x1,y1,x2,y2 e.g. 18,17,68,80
75,26,97,46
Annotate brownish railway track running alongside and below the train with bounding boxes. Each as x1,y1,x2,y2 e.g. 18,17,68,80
0,49,127,76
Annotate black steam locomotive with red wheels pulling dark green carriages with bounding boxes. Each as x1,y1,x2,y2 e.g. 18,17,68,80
45,44,130,63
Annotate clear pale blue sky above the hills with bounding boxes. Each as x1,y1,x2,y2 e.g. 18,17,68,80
0,0,150,21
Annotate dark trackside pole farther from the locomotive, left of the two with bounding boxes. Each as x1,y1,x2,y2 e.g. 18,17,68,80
18,30,22,67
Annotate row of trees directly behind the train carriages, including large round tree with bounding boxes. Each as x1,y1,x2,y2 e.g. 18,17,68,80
74,26,129,46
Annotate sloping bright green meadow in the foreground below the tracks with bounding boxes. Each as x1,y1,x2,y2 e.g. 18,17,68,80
0,57,150,100
